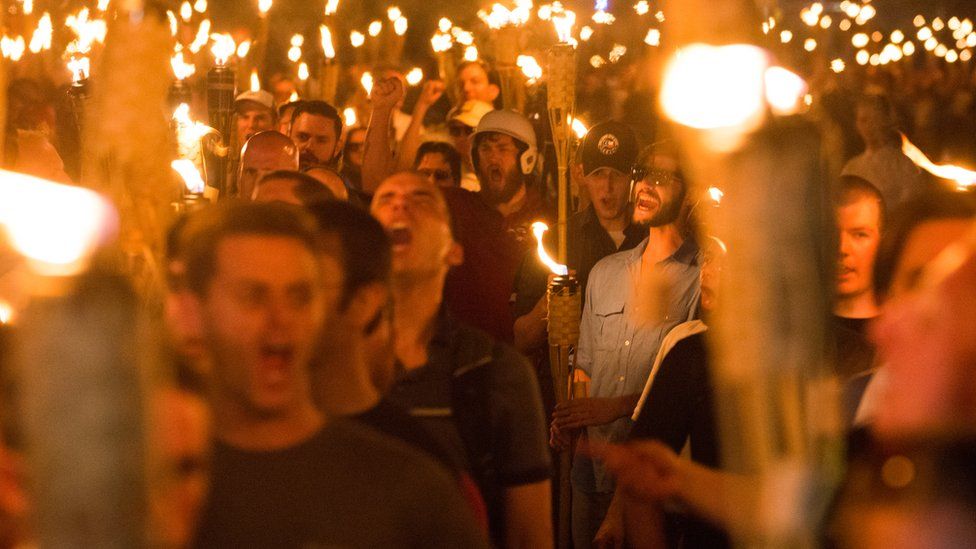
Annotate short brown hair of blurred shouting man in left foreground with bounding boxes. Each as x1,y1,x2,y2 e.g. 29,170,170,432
180,199,317,296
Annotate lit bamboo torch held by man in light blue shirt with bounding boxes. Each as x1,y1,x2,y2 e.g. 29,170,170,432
532,221,585,548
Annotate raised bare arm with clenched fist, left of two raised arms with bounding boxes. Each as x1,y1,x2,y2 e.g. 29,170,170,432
362,78,403,194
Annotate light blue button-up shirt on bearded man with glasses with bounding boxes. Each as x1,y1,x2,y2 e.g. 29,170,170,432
573,234,701,492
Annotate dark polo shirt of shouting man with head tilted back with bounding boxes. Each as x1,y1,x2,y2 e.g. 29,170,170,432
389,314,551,542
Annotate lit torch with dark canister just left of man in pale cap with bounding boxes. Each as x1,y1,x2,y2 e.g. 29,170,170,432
207,35,237,193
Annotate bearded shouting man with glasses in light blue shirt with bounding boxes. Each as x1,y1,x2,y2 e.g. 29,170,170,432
551,143,700,548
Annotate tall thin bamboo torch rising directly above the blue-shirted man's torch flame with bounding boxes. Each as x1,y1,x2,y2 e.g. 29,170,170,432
548,43,576,261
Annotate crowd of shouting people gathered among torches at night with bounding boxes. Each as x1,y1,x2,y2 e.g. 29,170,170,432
0,30,976,549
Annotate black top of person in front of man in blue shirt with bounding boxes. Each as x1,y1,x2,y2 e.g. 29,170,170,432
630,334,730,549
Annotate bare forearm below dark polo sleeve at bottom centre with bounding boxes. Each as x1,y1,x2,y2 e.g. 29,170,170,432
505,480,553,549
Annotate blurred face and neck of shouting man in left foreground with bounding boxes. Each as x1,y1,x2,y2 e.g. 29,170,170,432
192,235,324,418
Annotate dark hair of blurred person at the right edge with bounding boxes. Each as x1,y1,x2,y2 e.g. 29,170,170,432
874,190,976,301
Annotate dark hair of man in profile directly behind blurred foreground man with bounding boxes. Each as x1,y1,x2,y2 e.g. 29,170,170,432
307,201,393,308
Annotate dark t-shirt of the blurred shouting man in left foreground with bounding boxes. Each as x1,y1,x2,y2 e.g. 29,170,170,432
195,420,487,548
